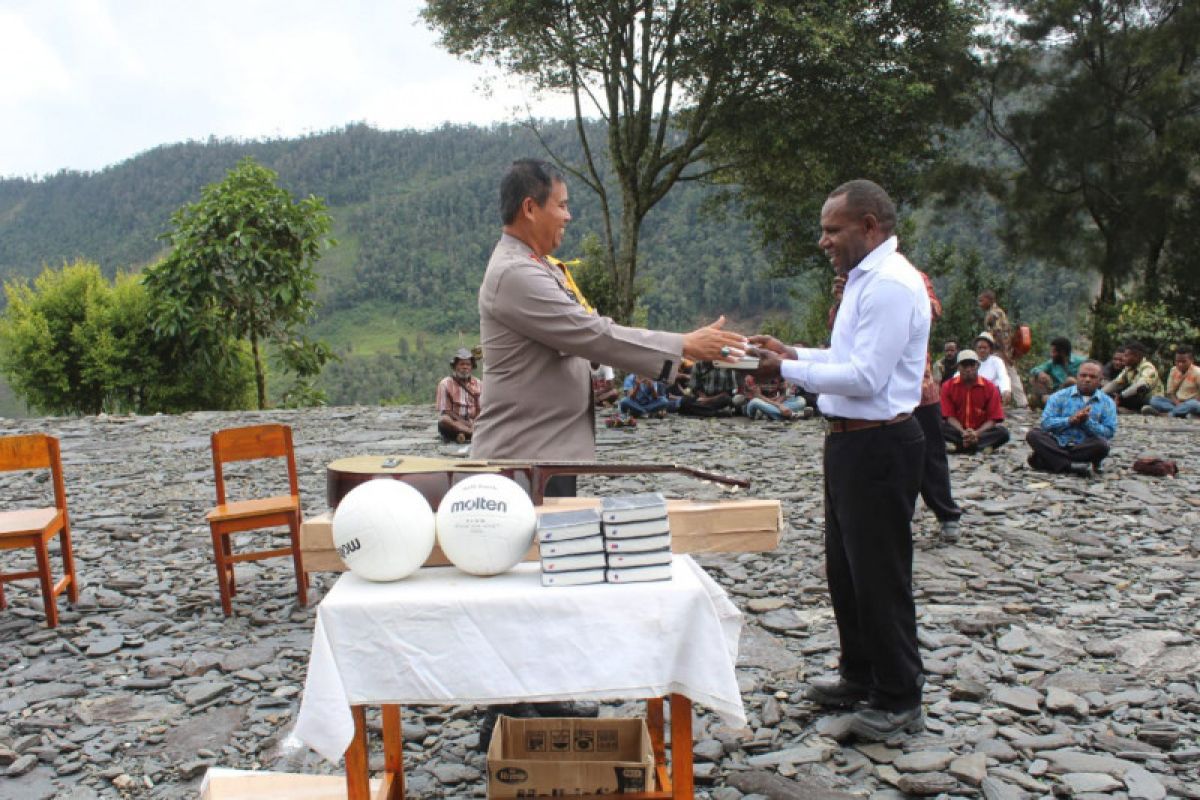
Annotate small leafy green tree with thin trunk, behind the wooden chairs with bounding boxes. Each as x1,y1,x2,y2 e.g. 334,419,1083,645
145,156,332,408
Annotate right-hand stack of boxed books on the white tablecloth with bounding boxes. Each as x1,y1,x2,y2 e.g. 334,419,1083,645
600,492,671,583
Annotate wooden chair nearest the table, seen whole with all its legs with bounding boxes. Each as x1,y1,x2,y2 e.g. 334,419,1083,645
205,425,308,616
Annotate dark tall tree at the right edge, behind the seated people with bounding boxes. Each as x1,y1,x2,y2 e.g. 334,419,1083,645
984,0,1200,355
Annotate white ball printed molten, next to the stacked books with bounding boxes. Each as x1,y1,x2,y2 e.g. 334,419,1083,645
438,475,538,575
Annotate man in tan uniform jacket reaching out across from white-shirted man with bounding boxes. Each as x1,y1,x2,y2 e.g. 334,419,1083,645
472,160,746,461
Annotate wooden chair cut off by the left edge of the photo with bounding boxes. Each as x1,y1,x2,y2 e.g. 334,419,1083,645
0,433,79,627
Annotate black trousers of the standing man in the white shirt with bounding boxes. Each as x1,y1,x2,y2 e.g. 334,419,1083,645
824,419,921,711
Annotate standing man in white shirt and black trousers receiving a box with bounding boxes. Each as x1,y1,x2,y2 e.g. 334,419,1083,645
750,180,942,741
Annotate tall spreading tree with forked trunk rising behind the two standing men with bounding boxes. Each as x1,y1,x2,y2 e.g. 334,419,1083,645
424,0,971,320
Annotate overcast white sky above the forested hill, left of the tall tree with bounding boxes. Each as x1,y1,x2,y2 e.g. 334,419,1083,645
0,0,571,176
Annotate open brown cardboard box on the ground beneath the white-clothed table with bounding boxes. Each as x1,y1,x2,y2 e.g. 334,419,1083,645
487,716,654,800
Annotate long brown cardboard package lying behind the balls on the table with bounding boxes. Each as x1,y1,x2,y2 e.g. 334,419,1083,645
300,498,784,572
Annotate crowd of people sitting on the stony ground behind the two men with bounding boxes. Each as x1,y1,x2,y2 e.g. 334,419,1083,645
437,303,1200,462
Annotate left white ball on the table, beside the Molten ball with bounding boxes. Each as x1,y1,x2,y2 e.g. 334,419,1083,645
334,477,437,581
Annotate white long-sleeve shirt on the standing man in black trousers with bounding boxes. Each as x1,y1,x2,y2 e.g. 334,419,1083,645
781,236,930,421
